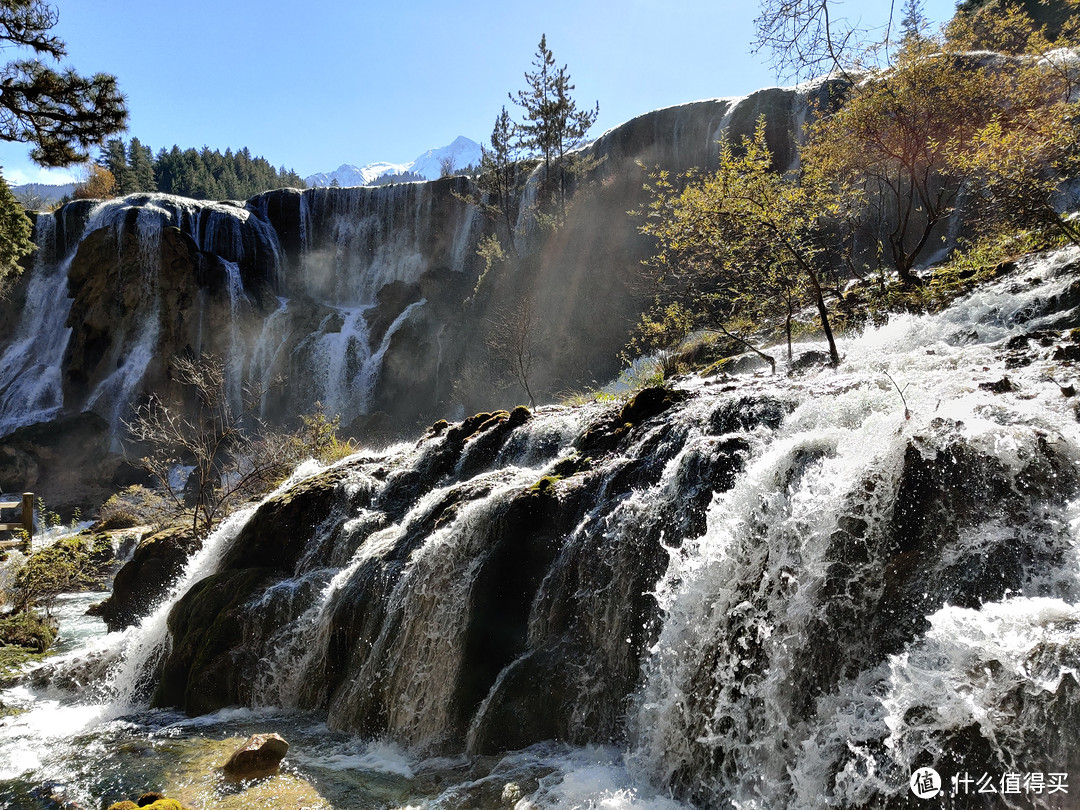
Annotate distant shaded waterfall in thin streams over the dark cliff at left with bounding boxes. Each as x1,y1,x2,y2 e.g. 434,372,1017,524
0,184,475,440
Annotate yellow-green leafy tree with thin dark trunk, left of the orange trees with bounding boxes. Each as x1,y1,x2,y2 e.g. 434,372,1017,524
636,117,847,368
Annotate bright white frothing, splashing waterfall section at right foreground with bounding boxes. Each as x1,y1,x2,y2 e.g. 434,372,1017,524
634,252,1080,810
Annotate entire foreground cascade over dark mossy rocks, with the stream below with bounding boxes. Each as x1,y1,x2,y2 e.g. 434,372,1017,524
0,252,1080,810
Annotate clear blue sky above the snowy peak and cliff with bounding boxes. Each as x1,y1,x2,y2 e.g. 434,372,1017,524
0,0,954,184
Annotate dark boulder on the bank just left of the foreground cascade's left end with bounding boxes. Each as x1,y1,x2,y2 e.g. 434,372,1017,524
94,526,202,632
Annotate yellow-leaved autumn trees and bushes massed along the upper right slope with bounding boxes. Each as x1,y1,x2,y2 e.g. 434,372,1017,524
631,0,1080,375
